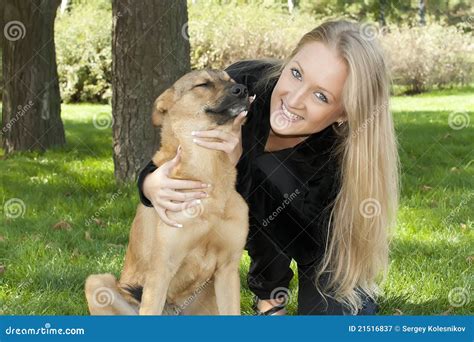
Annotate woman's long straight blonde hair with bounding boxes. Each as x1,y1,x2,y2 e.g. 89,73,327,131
257,20,400,314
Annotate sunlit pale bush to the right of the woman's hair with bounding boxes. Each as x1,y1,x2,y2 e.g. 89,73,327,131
381,24,474,93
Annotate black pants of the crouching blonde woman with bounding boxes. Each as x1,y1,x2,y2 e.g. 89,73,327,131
246,227,378,315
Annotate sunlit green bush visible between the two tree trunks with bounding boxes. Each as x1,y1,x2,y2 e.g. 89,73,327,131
55,0,112,103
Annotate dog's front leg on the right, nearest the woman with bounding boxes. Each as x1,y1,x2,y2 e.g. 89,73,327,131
214,259,240,315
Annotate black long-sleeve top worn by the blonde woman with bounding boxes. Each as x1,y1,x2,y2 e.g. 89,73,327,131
138,60,340,265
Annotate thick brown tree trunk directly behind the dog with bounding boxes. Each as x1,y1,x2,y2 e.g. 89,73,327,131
112,0,190,182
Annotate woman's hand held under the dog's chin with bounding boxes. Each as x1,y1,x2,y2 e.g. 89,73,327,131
192,111,247,166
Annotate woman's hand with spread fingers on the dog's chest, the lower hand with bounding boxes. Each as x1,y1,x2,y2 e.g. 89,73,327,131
143,147,210,227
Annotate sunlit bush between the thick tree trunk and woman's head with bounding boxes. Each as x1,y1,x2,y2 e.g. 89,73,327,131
188,2,317,68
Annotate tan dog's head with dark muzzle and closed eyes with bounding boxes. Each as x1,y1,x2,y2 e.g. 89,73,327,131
152,69,250,126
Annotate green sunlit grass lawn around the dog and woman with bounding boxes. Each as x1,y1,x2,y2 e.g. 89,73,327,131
0,89,474,315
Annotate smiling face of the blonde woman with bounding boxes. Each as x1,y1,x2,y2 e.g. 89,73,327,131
270,42,348,136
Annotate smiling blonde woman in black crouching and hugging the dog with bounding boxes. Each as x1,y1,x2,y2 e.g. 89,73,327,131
138,21,399,315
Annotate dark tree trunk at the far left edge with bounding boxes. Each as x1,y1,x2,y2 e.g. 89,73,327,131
1,0,66,154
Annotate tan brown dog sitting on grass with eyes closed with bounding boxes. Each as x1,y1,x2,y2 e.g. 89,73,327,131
85,70,251,315
